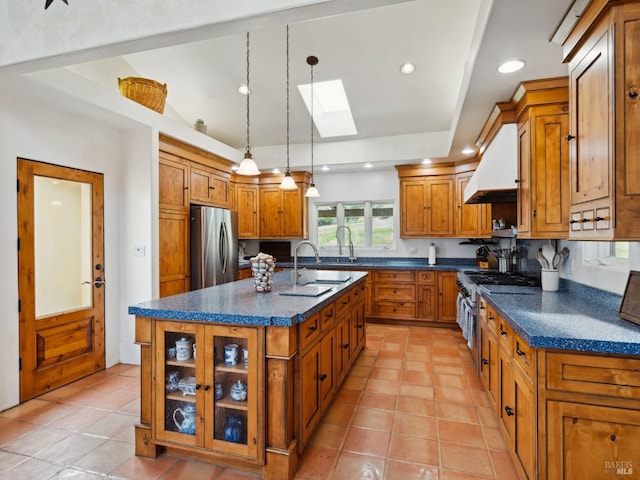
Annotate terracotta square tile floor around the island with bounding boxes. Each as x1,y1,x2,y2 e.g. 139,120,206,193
0,324,517,480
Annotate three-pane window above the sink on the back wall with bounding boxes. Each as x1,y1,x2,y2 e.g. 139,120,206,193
315,201,395,249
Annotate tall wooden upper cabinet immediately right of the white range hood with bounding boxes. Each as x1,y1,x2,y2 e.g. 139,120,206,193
512,77,570,238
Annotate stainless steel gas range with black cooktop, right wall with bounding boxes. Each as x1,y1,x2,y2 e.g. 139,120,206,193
457,270,540,369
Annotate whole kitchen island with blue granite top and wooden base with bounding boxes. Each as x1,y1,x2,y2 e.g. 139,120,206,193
129,270,367,480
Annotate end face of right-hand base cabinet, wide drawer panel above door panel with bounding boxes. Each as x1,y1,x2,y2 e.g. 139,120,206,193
539,351,640,480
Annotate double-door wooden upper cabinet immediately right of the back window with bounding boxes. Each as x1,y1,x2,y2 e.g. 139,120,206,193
400,175,455,237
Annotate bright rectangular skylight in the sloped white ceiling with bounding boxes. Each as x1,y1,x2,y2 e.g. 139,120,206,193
298,79,358,138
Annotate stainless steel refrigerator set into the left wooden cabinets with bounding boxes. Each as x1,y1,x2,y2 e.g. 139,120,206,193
191,206,238,290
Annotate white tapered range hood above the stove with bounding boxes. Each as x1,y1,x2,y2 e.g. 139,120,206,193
464,123,518,203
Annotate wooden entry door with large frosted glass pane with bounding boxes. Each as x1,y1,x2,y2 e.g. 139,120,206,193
18,159,105,402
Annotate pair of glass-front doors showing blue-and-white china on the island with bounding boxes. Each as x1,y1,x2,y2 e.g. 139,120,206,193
155,321,264,458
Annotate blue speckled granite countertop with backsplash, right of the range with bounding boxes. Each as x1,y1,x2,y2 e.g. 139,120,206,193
478,279,640,356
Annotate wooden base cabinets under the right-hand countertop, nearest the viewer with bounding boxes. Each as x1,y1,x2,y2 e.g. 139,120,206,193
478,297,640,480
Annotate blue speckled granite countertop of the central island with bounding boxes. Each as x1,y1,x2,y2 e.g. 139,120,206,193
129,270,367,326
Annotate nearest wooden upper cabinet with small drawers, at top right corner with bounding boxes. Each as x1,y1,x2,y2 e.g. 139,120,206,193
564,1,640,240
